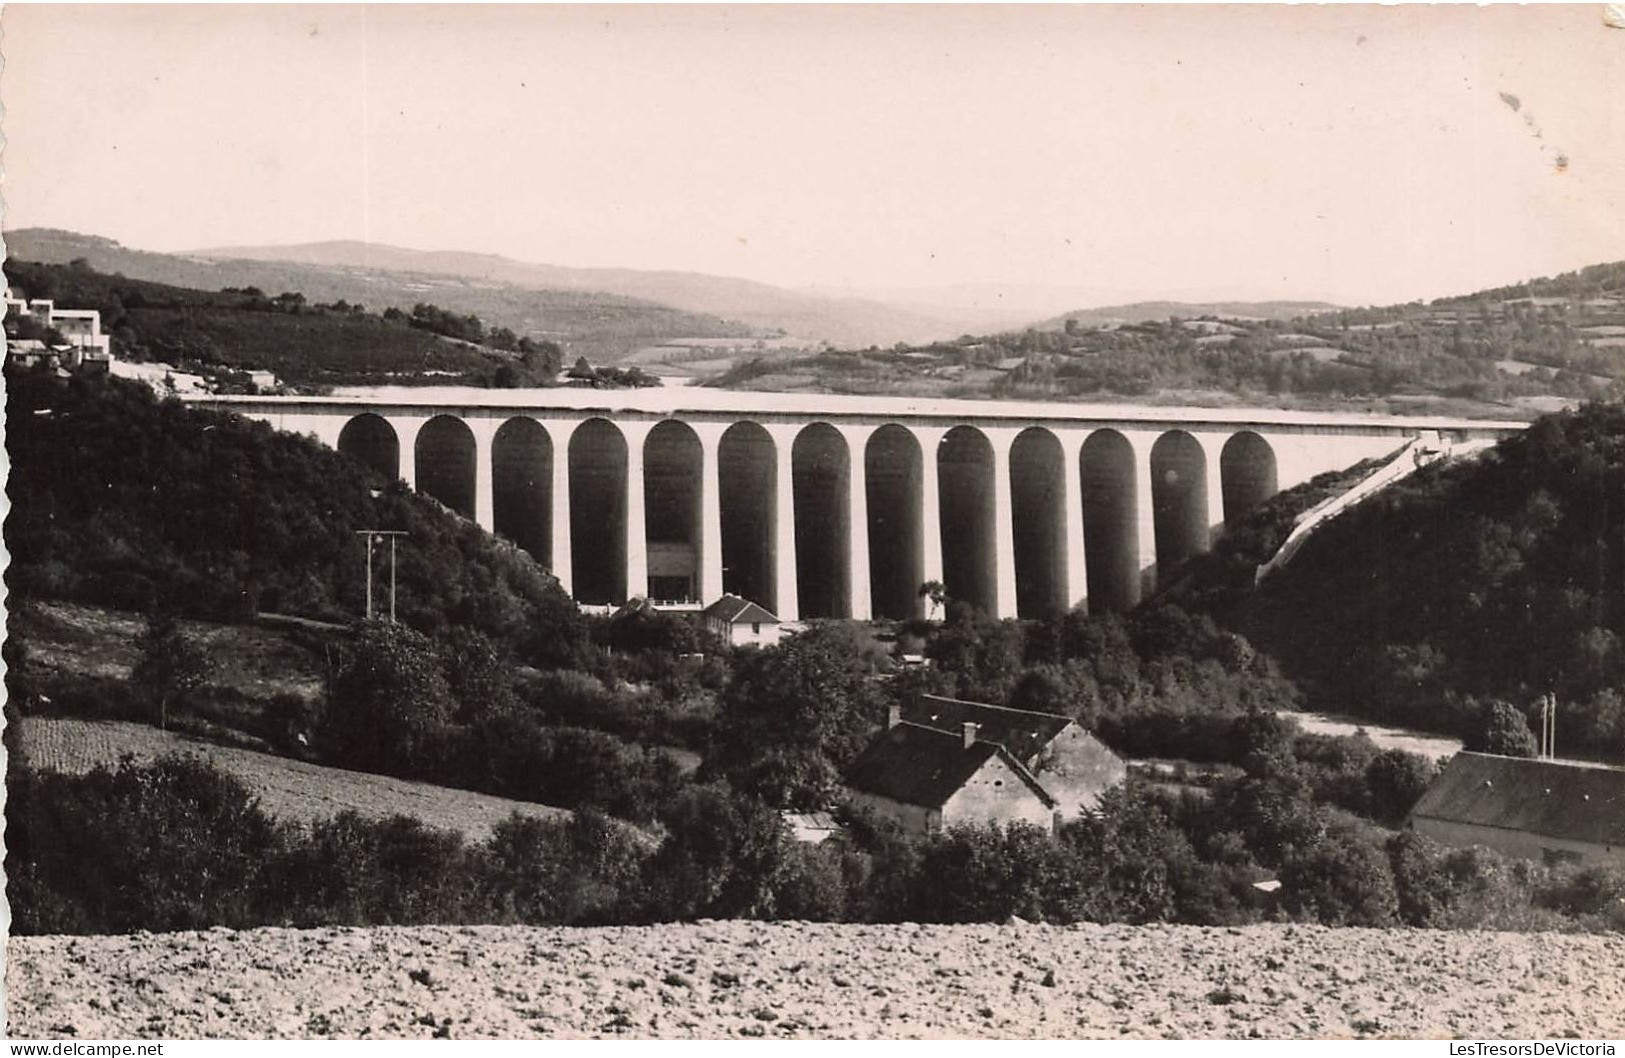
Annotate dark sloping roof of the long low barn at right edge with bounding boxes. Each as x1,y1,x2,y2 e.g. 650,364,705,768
1411,752,1625,845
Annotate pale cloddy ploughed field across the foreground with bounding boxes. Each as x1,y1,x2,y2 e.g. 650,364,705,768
7,921,1625,1038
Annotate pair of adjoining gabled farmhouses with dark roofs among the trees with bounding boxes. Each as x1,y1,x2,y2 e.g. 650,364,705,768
847,694,1128,835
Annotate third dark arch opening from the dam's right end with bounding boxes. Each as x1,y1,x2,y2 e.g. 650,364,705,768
1079,429,1139,613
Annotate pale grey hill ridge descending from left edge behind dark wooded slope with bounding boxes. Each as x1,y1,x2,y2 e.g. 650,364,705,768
5,228,759,362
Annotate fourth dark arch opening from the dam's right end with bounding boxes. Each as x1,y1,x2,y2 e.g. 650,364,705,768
1011,427,1071,618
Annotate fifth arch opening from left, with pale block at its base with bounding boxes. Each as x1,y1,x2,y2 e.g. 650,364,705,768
644,419,705,601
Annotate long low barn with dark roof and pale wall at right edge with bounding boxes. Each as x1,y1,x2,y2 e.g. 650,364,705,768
1411,752,1625,866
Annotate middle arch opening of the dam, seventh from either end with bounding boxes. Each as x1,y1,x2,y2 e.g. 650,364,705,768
790,423,852,618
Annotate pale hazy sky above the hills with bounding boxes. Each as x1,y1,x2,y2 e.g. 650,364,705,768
0,3,1625,302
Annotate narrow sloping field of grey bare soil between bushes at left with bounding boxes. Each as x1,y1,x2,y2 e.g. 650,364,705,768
18,717,569,842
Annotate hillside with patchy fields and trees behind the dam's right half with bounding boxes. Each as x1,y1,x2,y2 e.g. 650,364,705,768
712,265,1625,418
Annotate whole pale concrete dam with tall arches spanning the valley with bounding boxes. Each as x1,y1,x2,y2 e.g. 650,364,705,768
193,387,1524,621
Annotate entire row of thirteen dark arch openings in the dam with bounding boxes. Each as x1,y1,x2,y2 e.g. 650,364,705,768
338,413,1277,618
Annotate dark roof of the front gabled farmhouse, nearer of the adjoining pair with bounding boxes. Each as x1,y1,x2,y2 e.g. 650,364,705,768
847,720,1055,808
